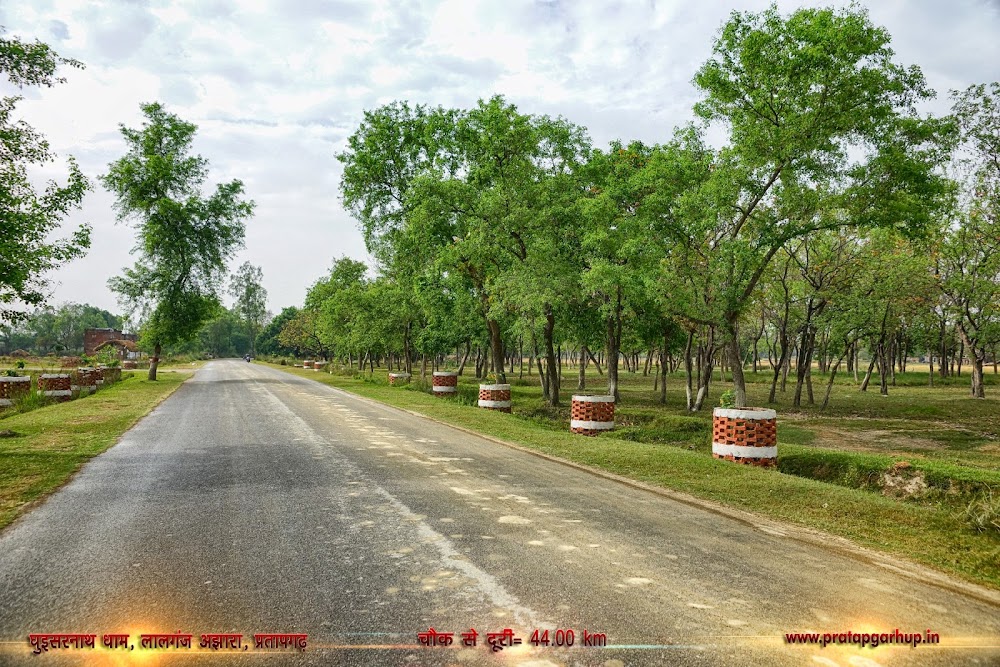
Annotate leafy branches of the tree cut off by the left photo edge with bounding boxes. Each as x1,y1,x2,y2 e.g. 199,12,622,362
0,28,90,322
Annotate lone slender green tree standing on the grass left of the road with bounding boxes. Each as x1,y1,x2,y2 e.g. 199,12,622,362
101,103,254,380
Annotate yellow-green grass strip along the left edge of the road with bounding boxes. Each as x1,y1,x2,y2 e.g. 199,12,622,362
0,373,189,528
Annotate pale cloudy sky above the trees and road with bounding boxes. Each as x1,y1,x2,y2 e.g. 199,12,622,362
0,0,1000,324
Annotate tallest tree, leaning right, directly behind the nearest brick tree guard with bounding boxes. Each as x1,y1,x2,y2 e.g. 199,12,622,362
695,5,943,406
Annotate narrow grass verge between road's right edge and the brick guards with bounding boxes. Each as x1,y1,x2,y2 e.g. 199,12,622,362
273,365,1000,589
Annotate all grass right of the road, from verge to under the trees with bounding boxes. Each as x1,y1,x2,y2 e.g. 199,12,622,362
264,365,1000,589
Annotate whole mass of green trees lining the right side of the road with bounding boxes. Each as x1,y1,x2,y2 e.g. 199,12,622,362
280,7,1000,410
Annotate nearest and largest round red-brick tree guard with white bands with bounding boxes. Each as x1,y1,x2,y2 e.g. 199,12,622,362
712,408,778,468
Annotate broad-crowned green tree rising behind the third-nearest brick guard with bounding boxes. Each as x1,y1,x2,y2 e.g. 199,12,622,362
338,96,586,388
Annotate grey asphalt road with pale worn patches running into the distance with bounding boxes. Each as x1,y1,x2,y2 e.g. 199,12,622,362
0,361,1000,667
